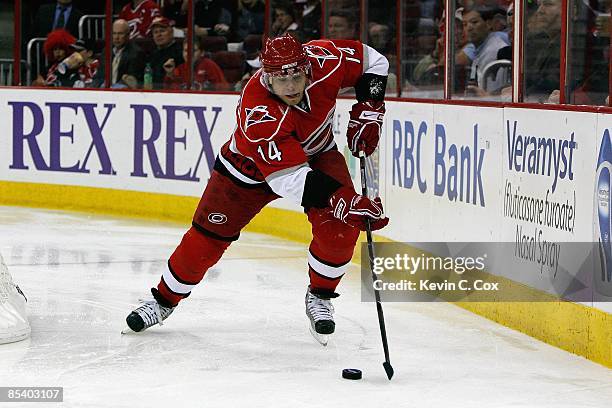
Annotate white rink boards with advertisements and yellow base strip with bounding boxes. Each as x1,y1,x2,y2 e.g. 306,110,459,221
0,89,612,366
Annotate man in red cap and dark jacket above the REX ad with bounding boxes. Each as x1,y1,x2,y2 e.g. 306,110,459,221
148,17,185,89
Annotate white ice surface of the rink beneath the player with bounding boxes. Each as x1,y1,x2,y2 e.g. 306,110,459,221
0,207,612,408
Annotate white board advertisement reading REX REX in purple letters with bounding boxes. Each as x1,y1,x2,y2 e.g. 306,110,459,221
0,89,237,197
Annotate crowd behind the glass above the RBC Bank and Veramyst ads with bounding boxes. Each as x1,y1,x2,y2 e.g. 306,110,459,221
401,0,610,105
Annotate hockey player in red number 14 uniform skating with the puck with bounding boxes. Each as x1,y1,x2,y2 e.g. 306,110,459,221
126,35,389,337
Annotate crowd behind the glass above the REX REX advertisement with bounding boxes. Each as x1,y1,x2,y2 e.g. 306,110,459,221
25,0,265,91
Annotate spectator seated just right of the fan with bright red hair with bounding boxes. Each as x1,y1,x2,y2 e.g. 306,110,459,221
55,40,104,88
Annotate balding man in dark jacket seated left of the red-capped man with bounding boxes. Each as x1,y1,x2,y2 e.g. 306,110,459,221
111,19,145,89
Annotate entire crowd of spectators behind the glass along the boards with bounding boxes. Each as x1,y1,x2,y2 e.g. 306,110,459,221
10,0,610,104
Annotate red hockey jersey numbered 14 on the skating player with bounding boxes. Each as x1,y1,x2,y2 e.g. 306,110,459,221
219,40,367,189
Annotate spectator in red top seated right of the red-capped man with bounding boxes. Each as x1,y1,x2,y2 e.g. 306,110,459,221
164,37,229,91
